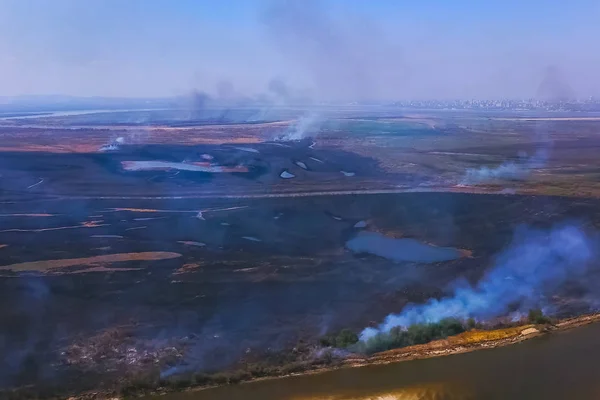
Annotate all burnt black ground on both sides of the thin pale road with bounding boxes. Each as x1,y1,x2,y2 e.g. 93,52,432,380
0,135,600,394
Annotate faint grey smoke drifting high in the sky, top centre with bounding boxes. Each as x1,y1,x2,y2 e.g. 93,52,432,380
263,0,403,100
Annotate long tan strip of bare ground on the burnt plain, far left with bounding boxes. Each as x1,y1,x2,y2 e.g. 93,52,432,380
0,251,181,272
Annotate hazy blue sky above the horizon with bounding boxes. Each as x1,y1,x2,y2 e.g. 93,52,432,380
0,0,600,99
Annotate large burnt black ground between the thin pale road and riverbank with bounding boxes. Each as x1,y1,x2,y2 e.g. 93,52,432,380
0,193,600,390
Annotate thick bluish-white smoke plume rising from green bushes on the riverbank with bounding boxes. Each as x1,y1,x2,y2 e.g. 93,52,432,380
361,225,596,340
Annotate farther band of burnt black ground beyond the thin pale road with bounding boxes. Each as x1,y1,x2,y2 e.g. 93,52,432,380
0,141,394,201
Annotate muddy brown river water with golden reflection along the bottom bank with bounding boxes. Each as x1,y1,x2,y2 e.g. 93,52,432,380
153,324,600,400
